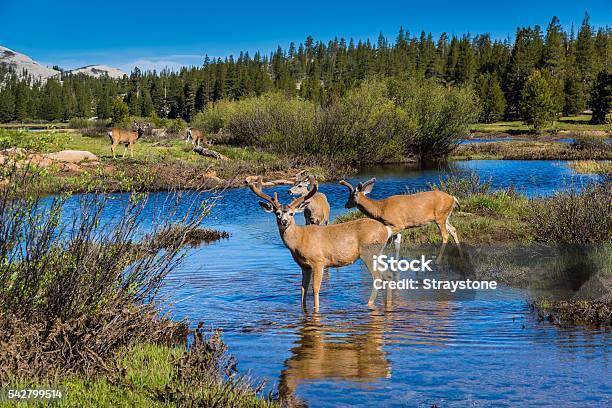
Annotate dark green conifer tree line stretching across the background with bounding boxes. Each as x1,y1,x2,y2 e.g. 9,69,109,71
0,14,612,127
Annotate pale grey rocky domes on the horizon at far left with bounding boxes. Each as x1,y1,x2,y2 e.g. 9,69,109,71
0,46,126,81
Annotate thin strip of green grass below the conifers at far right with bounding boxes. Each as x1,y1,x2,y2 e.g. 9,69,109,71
471,115,610,133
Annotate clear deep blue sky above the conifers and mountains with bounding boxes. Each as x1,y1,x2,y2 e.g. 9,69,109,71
0,0,612,71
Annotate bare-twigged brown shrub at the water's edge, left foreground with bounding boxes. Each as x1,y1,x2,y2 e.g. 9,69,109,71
0,166,206,383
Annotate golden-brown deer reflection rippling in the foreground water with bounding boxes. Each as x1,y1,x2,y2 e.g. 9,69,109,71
278,297,453,398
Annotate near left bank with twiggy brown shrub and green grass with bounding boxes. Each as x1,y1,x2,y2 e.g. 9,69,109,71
0,167,278,407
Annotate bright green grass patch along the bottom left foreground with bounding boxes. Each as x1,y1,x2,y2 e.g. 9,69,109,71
5,344,280,408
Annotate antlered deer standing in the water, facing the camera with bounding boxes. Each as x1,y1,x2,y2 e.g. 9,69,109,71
249,176,391,309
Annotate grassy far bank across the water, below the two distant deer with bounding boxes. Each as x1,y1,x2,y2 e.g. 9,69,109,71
0,130,350,193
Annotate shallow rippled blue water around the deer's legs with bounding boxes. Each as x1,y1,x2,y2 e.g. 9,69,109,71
93,161,612,407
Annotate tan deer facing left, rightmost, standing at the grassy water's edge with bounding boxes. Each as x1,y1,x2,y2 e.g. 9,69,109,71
340,178,459,256
